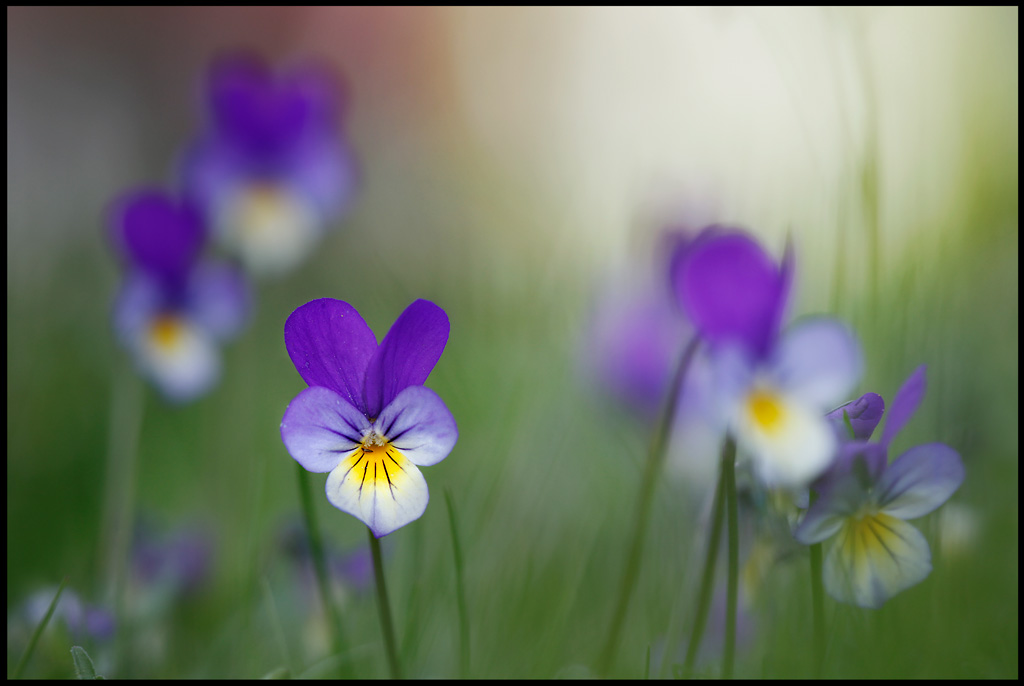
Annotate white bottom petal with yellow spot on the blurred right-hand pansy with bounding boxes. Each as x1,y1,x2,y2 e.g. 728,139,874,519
733,388,837,487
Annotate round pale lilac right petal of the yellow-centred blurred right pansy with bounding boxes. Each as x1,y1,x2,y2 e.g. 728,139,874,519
771,317,863,409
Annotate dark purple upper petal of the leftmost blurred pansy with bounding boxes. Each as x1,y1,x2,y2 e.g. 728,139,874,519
110,188,205,286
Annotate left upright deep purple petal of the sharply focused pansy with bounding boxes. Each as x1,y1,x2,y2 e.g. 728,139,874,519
285,298,377,417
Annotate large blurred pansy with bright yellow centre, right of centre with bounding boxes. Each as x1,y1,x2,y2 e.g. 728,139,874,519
672,231,861,486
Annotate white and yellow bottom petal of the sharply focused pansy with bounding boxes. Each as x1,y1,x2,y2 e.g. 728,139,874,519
327,446,430,539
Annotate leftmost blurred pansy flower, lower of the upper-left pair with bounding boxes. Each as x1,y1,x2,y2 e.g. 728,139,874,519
110,188,250,401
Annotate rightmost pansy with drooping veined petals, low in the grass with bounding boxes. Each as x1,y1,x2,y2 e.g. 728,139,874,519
795,367,964,607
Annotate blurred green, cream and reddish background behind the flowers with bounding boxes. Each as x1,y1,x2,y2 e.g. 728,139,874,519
7,7,1018,678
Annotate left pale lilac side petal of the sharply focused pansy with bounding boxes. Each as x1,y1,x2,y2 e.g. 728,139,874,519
281,386,370,472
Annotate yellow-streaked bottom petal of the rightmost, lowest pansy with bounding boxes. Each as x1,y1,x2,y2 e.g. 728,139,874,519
822,512,932,607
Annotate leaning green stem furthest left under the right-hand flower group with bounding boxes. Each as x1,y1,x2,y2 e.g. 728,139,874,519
598,337,698,675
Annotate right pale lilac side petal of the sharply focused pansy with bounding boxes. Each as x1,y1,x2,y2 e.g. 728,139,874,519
376,386,459,467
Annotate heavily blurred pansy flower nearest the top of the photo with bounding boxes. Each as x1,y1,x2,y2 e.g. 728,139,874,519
182,53,355,274
